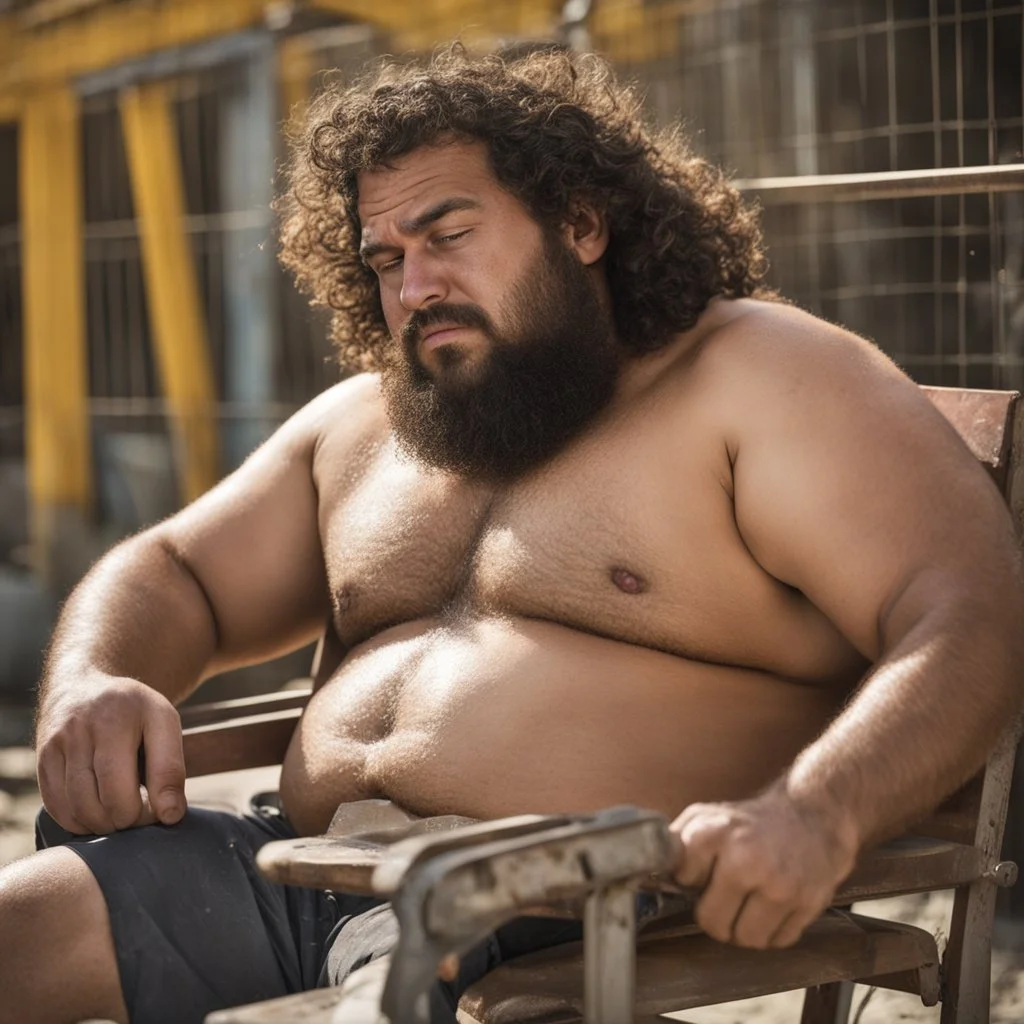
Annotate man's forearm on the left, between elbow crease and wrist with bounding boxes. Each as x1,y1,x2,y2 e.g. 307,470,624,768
39,531,217,709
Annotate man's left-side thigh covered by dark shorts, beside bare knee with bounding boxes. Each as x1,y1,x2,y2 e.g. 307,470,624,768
58,809,334,1024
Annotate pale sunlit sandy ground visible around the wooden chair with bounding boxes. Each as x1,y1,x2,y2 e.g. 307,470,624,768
6,748,1024,1024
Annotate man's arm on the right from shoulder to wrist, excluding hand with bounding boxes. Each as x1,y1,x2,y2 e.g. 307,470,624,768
733,316,1024,843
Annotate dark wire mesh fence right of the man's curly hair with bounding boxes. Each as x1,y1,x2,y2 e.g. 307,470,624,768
625,0,1024,387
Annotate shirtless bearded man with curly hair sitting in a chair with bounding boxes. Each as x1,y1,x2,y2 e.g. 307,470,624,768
0,41,1024,1022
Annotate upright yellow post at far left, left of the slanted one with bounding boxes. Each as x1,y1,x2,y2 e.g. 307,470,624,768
18,86,92,579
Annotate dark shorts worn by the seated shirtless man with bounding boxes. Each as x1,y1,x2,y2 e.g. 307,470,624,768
37,807,582,1024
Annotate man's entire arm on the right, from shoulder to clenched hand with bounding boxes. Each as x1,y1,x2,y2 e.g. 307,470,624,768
678,301,1024,945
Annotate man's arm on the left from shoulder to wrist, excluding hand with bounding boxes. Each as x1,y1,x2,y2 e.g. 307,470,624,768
42,385,328,707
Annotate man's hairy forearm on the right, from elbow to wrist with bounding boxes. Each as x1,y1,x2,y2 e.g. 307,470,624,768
777,606,1021,847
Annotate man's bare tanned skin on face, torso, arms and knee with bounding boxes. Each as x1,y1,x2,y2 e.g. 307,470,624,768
0,144,1024,1021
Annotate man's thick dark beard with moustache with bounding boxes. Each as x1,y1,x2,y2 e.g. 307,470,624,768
381,232,621,482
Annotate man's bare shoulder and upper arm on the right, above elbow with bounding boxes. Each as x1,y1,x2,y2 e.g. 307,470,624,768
671,302,1013,657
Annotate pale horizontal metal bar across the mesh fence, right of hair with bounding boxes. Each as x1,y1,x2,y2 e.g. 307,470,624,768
733,164,1024,206
